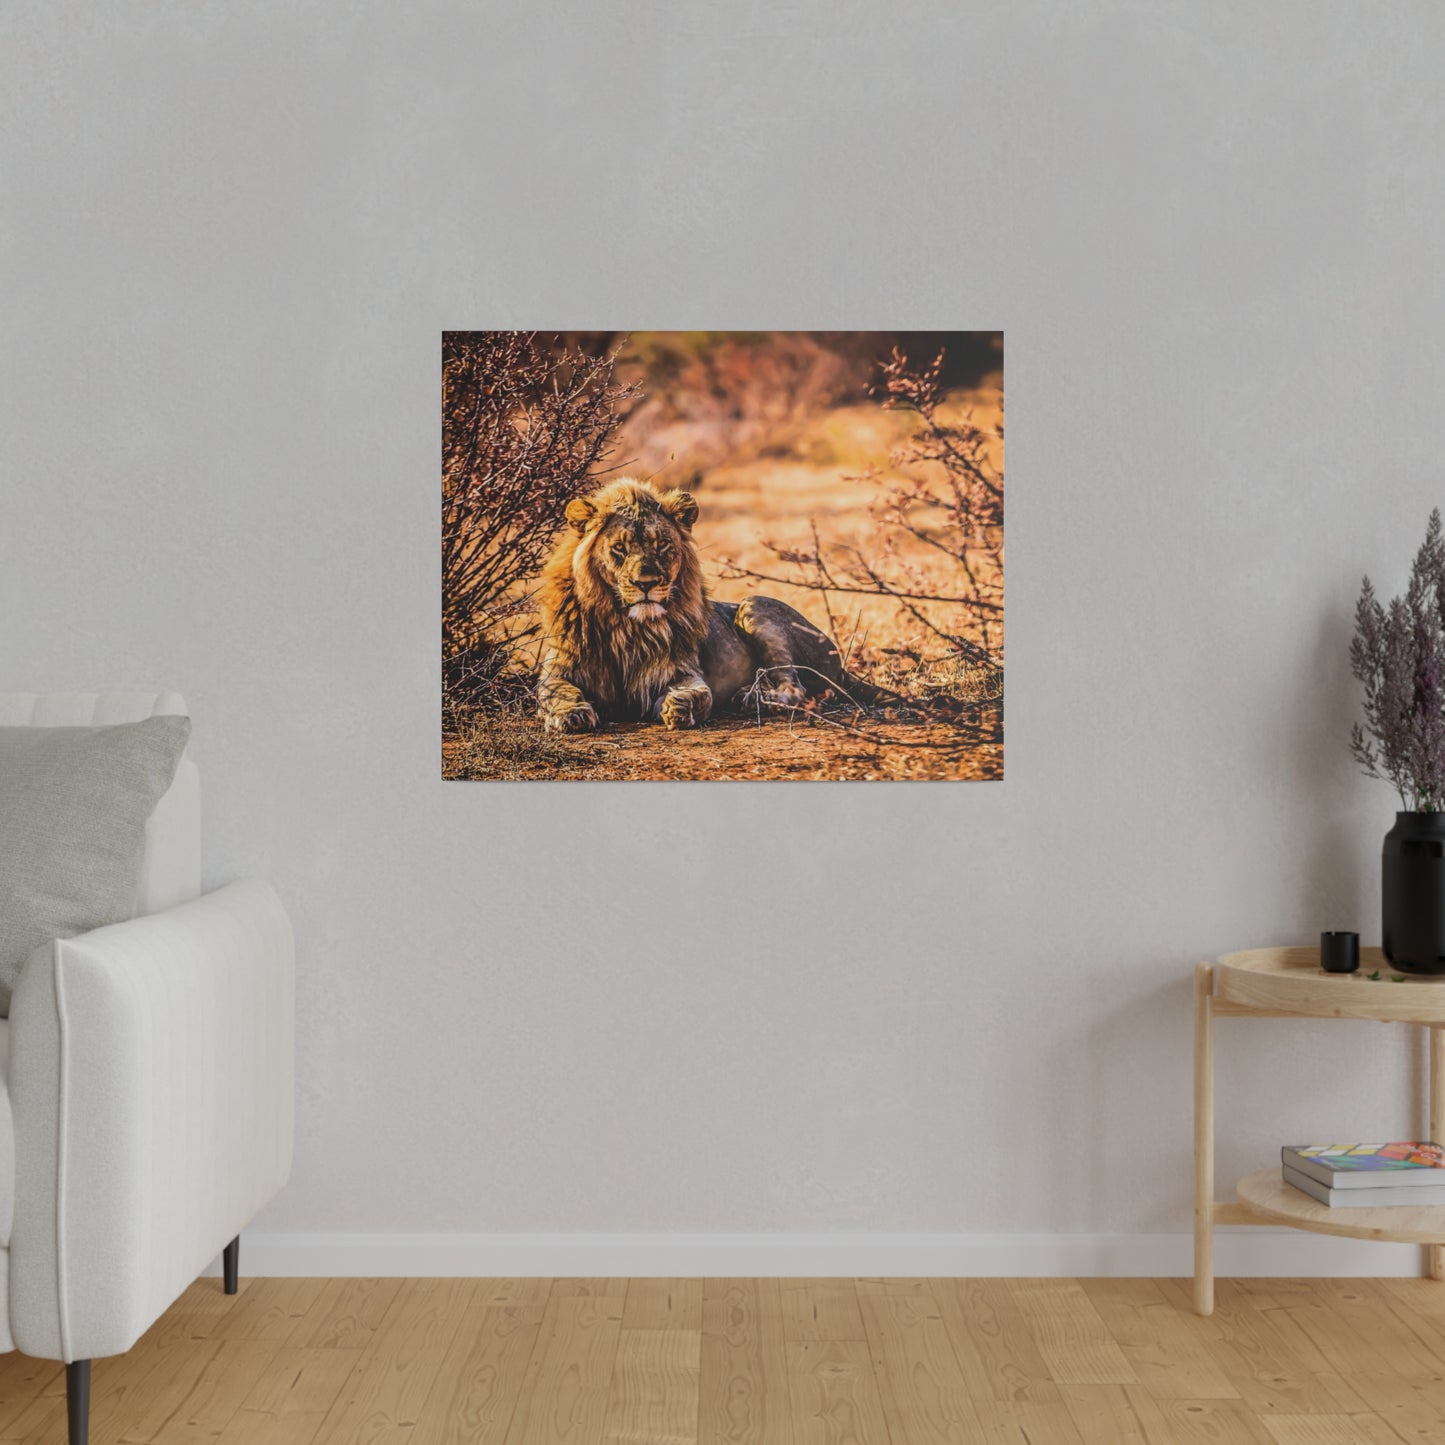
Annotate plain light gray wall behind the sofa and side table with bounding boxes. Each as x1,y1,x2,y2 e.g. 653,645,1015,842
0,0,1445,1231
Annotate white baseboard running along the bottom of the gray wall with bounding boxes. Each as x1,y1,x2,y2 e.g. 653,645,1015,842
210,1228,1422,1277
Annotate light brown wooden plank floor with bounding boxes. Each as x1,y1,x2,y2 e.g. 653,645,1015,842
8,1279,1445,1445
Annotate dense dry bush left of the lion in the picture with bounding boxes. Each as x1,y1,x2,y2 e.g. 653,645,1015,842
442,331,640,708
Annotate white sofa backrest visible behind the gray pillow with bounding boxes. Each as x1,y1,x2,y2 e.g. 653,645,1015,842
0,692,201,913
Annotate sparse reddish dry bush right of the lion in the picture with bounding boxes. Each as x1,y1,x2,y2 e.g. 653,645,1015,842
723,348,1003,702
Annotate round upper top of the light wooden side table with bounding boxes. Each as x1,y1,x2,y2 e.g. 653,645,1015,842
1214,946,1445,1025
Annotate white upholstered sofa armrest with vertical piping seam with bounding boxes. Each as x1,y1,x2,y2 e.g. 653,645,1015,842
10,880,295,1361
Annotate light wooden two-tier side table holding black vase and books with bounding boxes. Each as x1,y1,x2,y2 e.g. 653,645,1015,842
1194,948,1445,1315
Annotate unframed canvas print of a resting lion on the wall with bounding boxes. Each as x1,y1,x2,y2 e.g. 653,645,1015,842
441,331,1004,782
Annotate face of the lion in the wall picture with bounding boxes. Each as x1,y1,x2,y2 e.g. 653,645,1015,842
566,483,698,621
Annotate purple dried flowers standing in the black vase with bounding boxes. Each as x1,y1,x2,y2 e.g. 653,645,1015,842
1350,509,1445,812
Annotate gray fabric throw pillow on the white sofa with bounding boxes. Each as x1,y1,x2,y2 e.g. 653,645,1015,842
0,717,191,1016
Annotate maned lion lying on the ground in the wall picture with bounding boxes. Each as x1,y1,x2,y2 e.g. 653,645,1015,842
538,477,877,733
